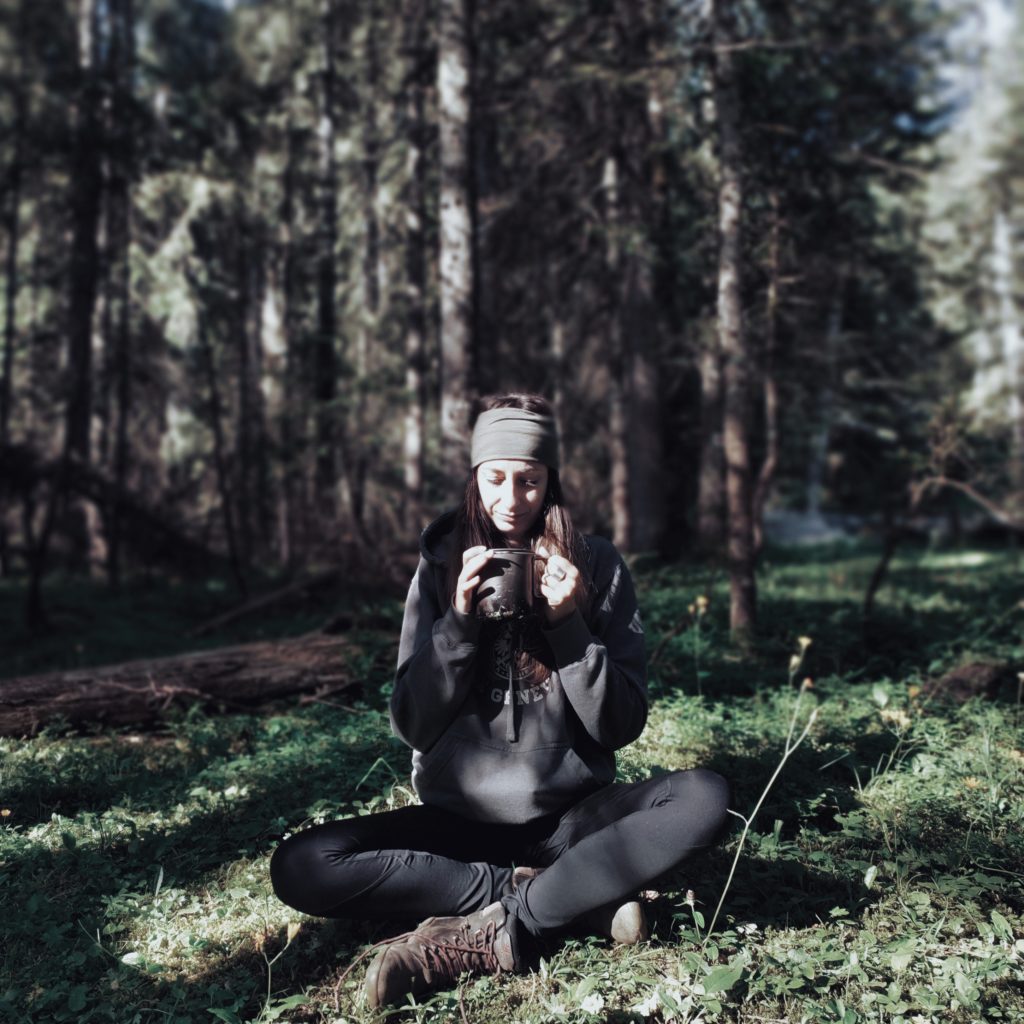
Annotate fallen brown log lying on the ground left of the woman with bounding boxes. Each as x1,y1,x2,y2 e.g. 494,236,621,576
0,633,359,736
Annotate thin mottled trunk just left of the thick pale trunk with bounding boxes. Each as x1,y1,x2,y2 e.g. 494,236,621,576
402,0,428,531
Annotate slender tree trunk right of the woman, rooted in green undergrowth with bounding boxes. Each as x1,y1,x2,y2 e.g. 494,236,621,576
713,0,757,642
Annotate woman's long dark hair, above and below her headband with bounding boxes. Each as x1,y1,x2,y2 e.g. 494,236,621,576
447,392,592,617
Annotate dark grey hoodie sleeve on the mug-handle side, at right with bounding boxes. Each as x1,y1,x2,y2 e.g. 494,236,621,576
545,540,647,750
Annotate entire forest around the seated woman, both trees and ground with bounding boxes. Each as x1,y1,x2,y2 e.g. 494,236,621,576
0,0,1024,1024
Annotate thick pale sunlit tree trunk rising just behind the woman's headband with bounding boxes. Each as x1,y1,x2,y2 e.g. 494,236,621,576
437,0,476,497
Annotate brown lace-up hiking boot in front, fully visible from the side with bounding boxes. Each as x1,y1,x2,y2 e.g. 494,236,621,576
362,903,516,1009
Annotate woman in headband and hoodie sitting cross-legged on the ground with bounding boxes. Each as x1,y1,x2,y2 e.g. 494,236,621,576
270,394,728,1007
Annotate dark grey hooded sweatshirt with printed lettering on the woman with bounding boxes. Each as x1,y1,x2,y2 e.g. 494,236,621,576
391,512,647,823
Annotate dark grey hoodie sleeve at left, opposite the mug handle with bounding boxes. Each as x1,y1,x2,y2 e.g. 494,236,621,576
391,558,480,751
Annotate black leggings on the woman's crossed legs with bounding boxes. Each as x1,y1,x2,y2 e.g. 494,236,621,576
270,768,728,936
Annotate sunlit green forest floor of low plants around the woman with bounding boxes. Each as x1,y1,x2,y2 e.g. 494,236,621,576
0,547,1024,1024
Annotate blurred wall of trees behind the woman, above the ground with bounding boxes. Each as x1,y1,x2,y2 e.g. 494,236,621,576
0,0,1024,630
